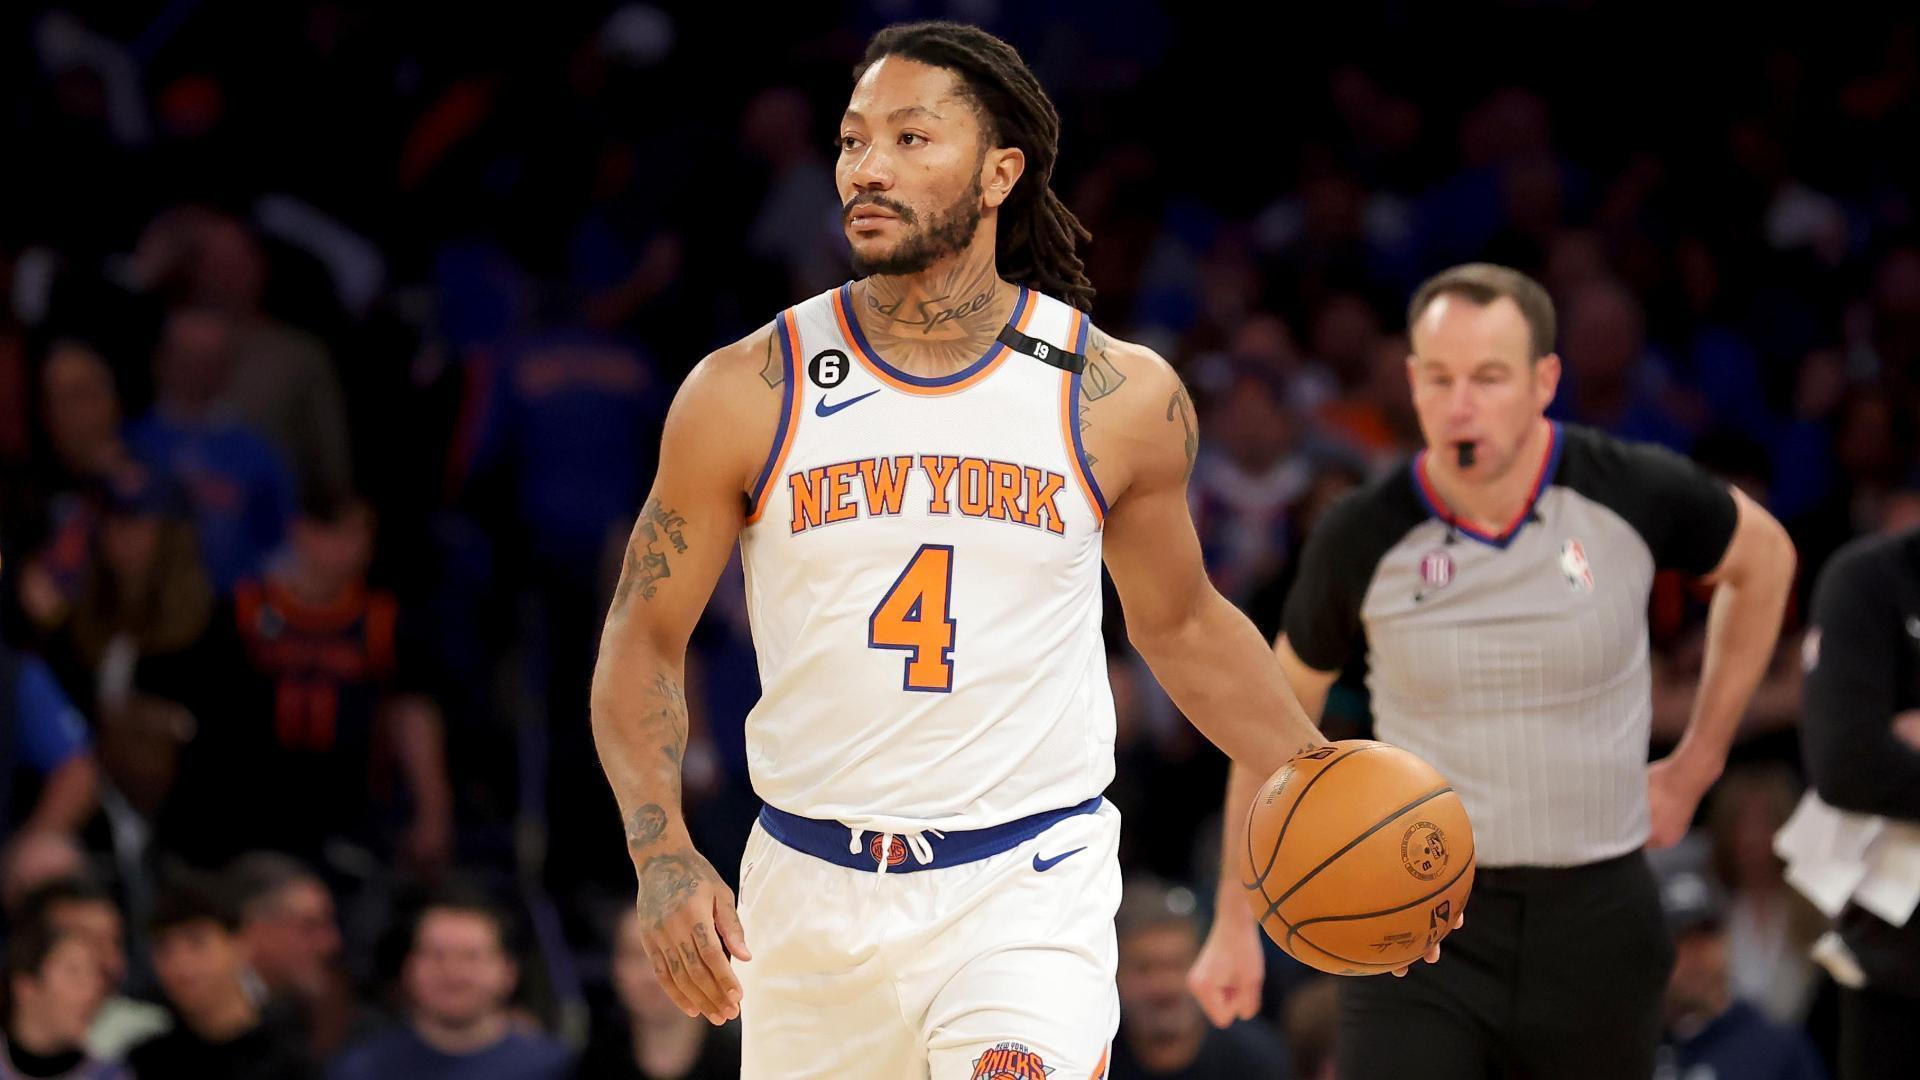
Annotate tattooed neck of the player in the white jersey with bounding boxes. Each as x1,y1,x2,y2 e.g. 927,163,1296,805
854,248,1018,377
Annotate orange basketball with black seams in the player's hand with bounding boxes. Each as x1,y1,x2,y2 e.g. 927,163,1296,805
1240,740,1473,974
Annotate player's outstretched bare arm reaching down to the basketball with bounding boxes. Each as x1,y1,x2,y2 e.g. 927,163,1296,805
1083,338,1323,776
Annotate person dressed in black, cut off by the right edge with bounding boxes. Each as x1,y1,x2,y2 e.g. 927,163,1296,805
1797,530,1920,1080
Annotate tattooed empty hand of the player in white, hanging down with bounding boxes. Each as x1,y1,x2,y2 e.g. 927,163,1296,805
634,838,753,1024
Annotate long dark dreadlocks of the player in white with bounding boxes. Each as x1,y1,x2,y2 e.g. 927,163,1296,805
854,21,1092,311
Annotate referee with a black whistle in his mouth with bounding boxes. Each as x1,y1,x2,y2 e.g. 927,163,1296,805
1188,263,1793,1080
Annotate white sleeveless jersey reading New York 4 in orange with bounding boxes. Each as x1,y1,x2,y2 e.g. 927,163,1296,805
741,284,1114,832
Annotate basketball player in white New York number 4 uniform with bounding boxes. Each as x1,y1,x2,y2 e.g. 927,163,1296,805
593,23,1397,1080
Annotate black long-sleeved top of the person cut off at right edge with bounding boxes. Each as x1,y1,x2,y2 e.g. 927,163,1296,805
1801,540,1920,821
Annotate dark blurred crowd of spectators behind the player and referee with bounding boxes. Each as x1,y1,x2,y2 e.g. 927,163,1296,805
0,0,1920,1080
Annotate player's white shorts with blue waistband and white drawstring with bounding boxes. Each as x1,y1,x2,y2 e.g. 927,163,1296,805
733,799,1121,1080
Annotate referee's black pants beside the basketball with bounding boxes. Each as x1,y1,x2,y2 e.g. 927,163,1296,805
1336,851,1674,1080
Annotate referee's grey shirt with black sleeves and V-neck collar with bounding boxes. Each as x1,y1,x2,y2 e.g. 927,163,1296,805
1284,425,1736,867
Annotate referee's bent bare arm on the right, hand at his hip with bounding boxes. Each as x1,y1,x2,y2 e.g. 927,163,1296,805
1649,488,1795,847
